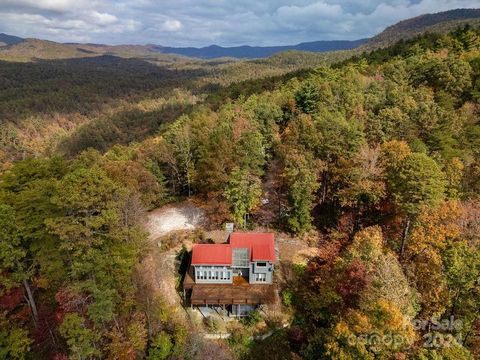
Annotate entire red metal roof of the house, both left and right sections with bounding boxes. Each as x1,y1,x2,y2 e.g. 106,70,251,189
192,232,275,265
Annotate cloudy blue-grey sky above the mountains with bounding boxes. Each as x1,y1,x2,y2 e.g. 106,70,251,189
0,0,480,46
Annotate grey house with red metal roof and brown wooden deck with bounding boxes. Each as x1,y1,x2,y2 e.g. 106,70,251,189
184,232,275,316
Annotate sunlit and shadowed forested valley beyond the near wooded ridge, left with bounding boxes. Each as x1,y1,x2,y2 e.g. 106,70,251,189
0,45,349,162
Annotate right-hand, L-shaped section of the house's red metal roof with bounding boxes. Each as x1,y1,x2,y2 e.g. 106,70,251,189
230,232,275,262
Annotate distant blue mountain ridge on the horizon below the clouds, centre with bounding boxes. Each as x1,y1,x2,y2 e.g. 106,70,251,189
151,39,368,59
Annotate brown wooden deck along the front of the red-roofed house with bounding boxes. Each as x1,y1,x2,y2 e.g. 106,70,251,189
183,267,275,305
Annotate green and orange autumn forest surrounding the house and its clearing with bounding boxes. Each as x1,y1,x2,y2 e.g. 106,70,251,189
0,25,480,360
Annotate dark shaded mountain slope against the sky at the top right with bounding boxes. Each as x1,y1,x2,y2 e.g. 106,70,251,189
359,9,480,50
